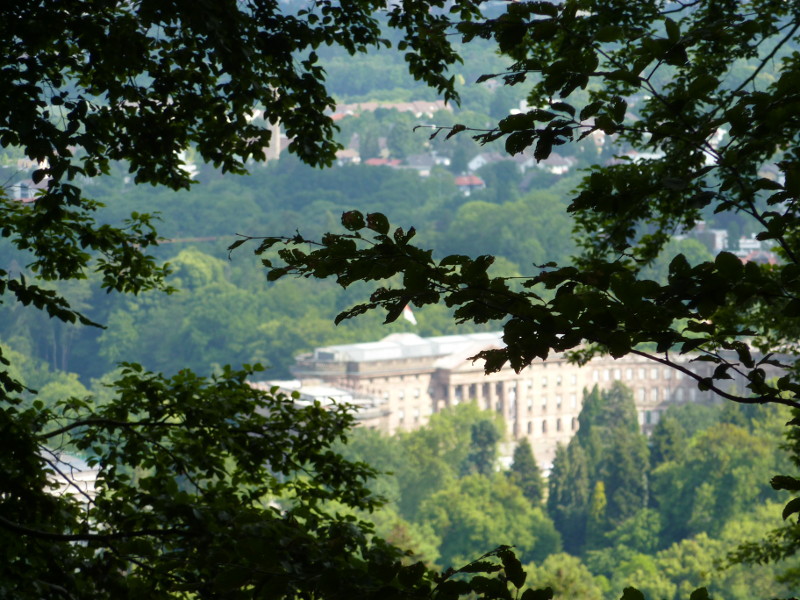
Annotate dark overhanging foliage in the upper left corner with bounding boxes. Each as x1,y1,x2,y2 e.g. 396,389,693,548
0,0,479,366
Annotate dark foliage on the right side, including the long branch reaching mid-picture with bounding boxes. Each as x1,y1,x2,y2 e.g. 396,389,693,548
260,1,800,407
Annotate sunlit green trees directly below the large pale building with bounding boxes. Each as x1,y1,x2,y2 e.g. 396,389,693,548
341,384,797,600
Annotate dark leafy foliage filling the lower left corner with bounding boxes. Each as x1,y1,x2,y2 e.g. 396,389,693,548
0,365,412,598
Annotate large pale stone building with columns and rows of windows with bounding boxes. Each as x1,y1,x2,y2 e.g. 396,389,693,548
272,332,728,468
